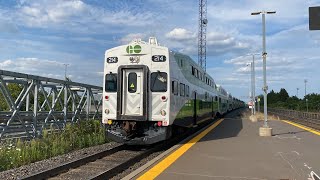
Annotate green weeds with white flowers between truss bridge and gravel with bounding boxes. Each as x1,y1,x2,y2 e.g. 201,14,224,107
0,120,107,171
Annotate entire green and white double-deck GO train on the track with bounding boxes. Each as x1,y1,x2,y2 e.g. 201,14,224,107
102,37,243,144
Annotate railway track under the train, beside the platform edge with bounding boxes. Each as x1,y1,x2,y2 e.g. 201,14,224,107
23,109,242,180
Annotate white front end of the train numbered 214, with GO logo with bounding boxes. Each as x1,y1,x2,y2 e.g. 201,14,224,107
103,38,171,144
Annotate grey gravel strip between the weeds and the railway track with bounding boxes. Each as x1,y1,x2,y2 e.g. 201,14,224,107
0,142,121,180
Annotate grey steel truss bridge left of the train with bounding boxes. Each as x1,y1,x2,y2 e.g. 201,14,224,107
0,70,102,140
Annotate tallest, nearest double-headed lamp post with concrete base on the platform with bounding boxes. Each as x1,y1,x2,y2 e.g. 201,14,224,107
251,11,276,136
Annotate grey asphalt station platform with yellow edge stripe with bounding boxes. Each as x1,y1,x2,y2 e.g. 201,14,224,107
134,112,320,180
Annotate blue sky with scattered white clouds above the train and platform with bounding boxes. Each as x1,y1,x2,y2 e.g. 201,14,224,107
0,0,320,99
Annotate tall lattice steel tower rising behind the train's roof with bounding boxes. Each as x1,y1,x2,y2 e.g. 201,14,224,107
198,0,208,72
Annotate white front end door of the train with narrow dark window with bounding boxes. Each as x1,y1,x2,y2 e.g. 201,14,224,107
122,69,144,116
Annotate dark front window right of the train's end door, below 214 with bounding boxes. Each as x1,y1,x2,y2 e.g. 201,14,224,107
151,72,167,92
